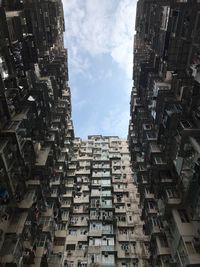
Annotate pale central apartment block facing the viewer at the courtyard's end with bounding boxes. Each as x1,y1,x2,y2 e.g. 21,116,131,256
64,135,149,267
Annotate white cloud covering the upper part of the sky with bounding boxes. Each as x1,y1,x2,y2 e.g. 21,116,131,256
63,0,136,79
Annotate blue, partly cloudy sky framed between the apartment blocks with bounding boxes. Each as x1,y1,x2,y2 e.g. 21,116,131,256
63,0,137,138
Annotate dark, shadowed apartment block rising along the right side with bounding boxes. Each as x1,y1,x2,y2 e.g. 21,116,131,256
128,0,200,267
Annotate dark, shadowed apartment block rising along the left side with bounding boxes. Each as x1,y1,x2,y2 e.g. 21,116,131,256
0,0,74,267
